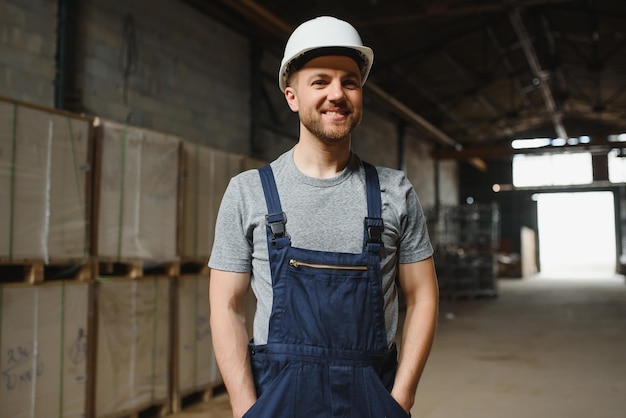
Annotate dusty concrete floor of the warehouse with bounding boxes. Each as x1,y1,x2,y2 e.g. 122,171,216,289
170,276,626,418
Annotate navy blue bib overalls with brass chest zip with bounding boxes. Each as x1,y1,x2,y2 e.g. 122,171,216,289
244,163,408,418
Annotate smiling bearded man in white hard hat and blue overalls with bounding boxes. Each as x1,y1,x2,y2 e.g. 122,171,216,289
209,17,438,418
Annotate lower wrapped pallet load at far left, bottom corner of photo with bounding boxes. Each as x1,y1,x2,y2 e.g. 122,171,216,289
0,282,90,418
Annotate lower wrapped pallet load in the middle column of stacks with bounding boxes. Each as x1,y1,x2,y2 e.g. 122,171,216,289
95,277,171,417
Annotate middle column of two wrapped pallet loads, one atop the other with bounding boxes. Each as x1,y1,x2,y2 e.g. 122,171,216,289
92,120,182,417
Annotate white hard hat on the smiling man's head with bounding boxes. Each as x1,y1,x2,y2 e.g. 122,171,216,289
278,16,374,92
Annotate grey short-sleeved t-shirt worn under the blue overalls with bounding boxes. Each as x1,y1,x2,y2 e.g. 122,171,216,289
209,149,433,344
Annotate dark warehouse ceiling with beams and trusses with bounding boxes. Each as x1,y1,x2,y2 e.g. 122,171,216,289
187,0,626,162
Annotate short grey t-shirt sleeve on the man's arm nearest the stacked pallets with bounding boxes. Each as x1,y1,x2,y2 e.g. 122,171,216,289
209,175,252,273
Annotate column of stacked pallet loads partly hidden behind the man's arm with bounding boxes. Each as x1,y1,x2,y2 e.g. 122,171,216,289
172,141,264,412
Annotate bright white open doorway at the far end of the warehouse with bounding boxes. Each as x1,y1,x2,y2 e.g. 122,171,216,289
537,192,616,277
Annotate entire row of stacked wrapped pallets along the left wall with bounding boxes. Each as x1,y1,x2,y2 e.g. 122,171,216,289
0,98,264,418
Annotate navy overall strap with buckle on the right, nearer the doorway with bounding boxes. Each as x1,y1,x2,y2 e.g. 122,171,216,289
363,161,384,253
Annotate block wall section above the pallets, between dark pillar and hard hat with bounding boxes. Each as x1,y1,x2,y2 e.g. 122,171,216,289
78,0,250,154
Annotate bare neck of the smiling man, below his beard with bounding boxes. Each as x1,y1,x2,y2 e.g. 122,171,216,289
293,137,351,179
